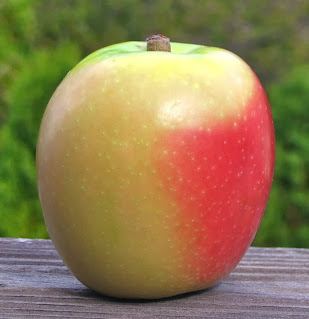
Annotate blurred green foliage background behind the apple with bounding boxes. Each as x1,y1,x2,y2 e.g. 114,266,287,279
0,0,309,247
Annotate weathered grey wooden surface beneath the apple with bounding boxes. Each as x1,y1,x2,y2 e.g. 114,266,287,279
0,238,309,319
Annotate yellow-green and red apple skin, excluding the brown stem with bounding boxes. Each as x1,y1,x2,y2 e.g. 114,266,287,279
37,42,275,299
